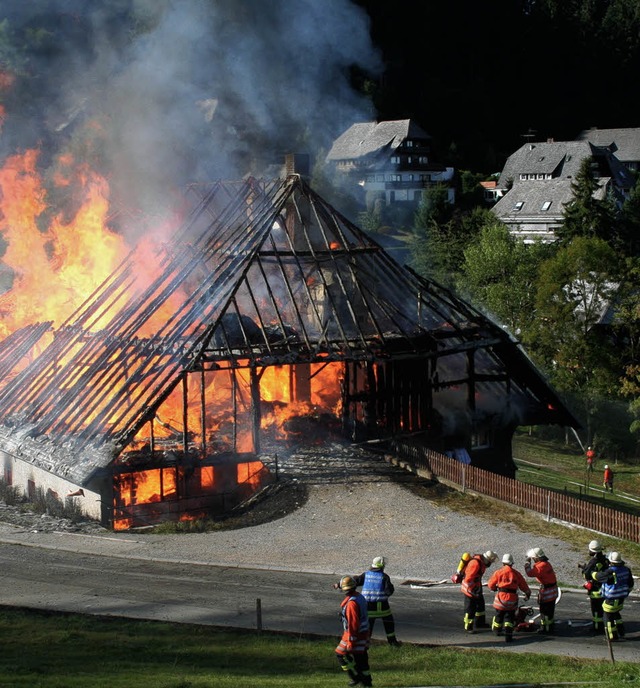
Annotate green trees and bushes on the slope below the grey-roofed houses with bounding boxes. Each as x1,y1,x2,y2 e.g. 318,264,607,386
404,158,640,457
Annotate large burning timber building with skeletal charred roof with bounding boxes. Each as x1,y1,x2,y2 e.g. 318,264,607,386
0,169,577,529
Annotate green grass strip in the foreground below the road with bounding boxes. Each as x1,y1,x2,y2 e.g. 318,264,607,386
0,608,640,688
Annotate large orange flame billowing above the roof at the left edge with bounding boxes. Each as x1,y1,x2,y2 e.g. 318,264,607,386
0,150,129,337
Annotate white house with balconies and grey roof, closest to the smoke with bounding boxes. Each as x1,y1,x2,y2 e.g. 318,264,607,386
326,119,455,205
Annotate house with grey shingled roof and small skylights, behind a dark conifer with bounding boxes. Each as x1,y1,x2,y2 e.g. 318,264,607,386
492,141,634,243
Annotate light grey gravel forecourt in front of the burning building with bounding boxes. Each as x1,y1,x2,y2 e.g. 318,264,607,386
186,444,590,585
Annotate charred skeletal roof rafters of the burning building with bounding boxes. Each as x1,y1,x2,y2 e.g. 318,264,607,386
0,175,578,482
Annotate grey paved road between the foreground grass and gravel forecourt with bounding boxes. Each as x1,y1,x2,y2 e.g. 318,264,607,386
0,532,640,662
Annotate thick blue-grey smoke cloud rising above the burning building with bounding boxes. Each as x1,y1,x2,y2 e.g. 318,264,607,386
0,0,379,228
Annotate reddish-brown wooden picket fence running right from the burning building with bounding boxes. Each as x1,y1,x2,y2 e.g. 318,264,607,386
392,441,640,542
